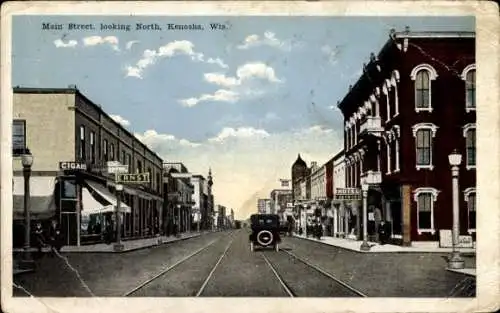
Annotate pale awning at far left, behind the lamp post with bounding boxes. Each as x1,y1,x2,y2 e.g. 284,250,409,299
12,176,56,220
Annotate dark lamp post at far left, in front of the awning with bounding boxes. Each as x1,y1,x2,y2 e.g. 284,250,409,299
21,149,34,268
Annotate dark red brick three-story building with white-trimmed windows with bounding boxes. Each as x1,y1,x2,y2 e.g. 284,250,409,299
338,29,476,245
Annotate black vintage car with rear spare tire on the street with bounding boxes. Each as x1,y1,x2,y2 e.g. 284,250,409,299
249,214,281,251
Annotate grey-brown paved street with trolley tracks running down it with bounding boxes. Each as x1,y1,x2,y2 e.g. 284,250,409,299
10,229,475,297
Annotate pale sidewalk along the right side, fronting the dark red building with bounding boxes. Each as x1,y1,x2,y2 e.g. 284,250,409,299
295,235,476,254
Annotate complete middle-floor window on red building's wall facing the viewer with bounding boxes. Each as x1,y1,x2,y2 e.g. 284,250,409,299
412,123,438,170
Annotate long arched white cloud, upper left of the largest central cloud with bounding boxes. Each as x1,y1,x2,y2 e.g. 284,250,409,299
126,40,228,78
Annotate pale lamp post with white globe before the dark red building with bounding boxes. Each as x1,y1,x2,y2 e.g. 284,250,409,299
448,150,464,269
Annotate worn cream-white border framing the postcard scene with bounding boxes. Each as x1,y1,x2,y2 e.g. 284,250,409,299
0,1,500,313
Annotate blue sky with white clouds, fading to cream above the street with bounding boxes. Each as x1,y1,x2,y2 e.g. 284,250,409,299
12,15,475,218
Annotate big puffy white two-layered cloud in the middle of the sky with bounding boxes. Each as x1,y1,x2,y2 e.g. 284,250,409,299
179,62,282,107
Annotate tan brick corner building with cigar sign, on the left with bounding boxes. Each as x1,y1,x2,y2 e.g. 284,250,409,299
12,86,163,245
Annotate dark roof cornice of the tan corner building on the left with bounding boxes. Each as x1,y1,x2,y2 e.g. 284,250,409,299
12,86,163,163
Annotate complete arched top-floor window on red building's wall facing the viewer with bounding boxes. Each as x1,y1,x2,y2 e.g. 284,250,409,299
410,64,438,112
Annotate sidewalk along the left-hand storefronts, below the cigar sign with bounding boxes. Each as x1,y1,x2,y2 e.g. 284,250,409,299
13,231,212,253
